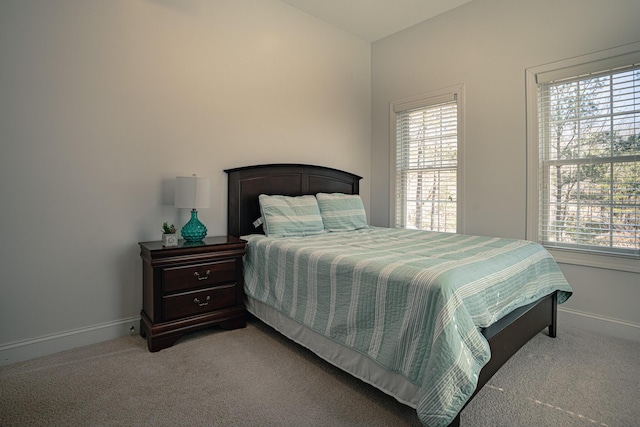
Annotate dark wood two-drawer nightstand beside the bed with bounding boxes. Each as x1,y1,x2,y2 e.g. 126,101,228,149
139,236,246,351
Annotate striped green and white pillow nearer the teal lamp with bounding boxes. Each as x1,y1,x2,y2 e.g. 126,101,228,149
258,194,324,237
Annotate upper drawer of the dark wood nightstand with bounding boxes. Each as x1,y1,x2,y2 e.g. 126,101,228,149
162,259,239,292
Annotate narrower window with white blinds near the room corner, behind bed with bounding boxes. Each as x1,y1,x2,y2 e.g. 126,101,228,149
391,86,463,233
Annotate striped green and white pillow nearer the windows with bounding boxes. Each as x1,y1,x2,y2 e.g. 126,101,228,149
316,193,368,231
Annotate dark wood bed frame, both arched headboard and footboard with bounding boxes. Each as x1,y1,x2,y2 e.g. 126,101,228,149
225,164,557,427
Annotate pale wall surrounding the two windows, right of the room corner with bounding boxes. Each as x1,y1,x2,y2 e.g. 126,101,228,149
371,0,640,340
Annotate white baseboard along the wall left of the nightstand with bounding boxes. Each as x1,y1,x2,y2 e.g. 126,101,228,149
0,316,140,366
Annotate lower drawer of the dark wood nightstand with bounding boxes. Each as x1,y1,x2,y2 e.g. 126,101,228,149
162,284,237,321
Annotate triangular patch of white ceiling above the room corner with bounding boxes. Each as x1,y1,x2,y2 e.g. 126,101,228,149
282,0,471,42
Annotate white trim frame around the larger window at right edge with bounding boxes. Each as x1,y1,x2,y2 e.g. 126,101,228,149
525,42,640,273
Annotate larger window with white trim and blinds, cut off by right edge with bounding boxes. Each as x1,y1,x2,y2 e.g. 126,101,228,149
527,43,640,266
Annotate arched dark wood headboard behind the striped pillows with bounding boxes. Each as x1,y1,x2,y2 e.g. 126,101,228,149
225,164,362,237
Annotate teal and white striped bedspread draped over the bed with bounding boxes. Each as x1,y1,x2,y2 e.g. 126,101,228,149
244,227,571,426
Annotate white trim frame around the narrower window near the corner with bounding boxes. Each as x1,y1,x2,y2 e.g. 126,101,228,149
389,84,465,233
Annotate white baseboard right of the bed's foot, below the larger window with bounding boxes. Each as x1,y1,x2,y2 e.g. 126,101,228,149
558,307,640,342
